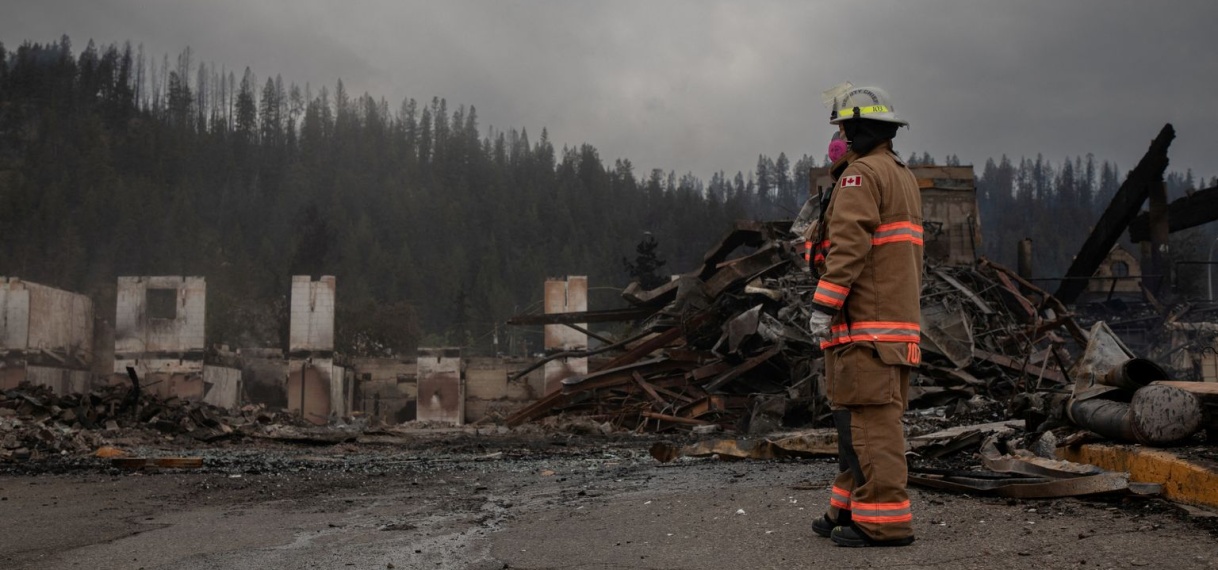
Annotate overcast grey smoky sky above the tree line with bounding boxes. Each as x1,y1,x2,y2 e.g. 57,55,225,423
0,0,1218,179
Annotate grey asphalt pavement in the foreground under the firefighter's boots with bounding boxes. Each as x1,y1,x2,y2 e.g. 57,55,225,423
0,445,1218,570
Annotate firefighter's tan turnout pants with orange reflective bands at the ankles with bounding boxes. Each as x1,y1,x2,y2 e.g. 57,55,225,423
825,342,914,541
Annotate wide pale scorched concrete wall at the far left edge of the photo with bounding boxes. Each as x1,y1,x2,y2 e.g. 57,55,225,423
0,276,94,395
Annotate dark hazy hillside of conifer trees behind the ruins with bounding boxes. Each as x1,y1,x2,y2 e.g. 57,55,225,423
0,37,1213,354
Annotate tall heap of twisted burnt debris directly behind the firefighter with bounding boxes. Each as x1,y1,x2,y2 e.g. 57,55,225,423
508,222,1198,432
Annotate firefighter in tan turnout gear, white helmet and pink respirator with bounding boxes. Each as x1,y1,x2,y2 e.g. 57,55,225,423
809,86,922,547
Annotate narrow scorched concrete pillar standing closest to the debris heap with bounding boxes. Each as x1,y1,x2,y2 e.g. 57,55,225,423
544,275,588,393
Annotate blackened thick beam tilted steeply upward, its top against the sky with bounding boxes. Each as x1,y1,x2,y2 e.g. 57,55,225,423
1054,124,1175,304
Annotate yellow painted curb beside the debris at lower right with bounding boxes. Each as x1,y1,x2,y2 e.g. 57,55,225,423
1057,443,1218,507
